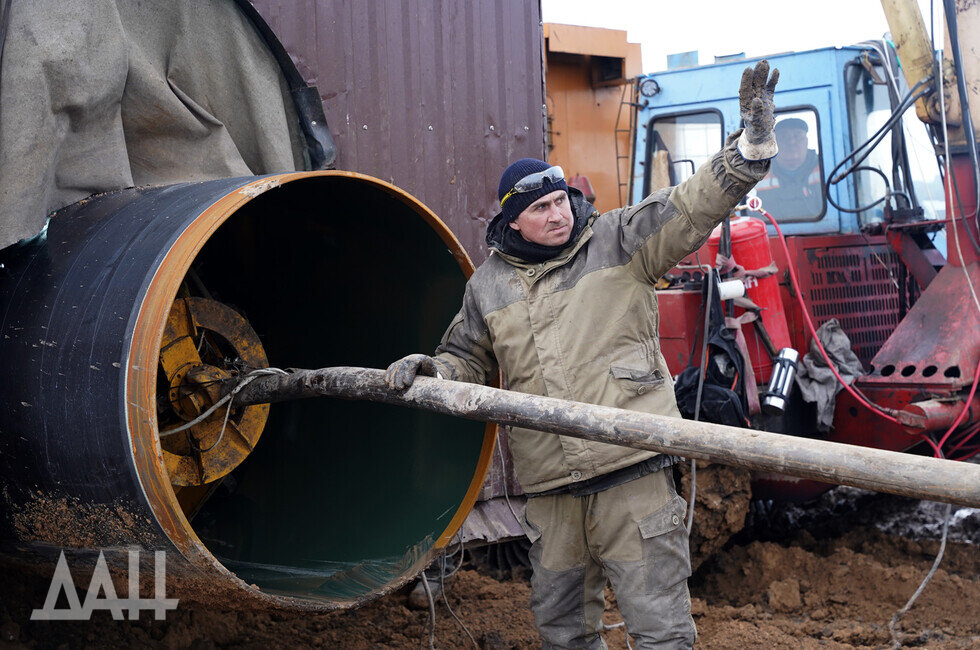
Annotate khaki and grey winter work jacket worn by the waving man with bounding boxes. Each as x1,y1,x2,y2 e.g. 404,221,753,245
436,138,769,492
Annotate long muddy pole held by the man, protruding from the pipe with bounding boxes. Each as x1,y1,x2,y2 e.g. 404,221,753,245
234,367,980,508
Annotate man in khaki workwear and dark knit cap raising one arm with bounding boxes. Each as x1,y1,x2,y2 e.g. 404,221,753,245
386,61,779,648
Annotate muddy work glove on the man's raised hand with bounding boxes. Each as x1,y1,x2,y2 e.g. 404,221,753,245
738,59,779,160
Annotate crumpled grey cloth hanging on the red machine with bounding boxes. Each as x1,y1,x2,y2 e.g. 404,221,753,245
796,318,865,431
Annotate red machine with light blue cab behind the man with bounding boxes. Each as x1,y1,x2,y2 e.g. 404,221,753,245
632,12,980,499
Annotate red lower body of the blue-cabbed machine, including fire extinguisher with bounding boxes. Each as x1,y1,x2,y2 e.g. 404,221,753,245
658,157,980,500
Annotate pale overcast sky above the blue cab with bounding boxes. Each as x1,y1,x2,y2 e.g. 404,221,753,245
541,0,942,72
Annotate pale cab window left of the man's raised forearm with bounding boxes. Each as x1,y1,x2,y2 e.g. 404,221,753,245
643,110,724,194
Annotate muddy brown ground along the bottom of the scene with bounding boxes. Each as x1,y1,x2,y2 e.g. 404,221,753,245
0,488,980,649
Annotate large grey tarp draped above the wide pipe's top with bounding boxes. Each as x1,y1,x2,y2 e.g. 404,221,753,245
0,0,307,248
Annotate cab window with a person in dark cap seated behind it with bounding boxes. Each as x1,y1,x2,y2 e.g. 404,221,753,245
755,108,826,221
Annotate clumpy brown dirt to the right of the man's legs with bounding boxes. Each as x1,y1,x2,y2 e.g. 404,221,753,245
692,531,980,648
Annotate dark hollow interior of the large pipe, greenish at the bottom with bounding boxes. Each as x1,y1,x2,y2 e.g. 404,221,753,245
181,177,484,603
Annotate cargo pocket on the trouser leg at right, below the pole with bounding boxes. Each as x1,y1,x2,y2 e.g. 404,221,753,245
638,496,691,592
